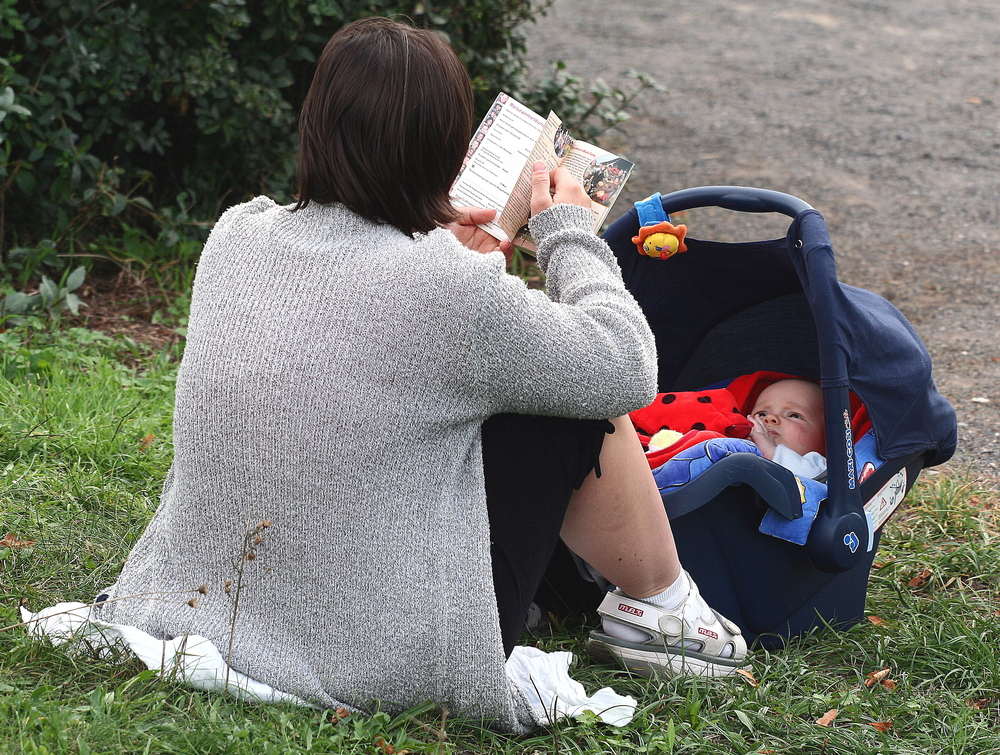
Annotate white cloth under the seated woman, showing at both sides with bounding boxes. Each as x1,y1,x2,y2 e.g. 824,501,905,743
21,603,636,726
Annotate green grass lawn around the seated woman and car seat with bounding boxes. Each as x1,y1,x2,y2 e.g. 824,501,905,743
0,324,1000,755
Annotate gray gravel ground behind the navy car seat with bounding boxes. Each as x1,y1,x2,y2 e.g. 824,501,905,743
528,0,1000,488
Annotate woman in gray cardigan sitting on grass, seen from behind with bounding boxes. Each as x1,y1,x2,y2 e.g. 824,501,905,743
101,19,746,731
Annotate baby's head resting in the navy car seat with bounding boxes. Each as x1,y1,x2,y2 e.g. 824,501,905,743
750,380,826,454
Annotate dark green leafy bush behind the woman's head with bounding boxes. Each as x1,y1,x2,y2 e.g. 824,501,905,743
0,0,656,286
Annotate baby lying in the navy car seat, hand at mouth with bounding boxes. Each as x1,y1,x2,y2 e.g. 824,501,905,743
747,379,826,479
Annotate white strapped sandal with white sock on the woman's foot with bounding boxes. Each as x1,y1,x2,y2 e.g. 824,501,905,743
587,576,747,676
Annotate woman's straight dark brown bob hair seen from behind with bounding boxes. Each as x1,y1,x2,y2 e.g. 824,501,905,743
295,18,472,234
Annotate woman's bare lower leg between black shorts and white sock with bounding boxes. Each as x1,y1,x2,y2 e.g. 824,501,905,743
560,417,681,598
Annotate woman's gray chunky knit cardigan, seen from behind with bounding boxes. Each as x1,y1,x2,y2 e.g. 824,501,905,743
101,197,656,732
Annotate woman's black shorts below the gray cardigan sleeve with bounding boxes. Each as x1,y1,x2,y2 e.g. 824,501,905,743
483,414,614,655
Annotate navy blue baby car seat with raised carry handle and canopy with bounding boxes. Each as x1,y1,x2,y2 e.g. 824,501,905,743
592,186,956,647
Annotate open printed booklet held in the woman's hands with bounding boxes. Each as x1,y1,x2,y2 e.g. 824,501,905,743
451,92,633,251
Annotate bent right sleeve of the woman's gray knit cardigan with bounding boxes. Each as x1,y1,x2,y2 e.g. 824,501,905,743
474,205,657,419
